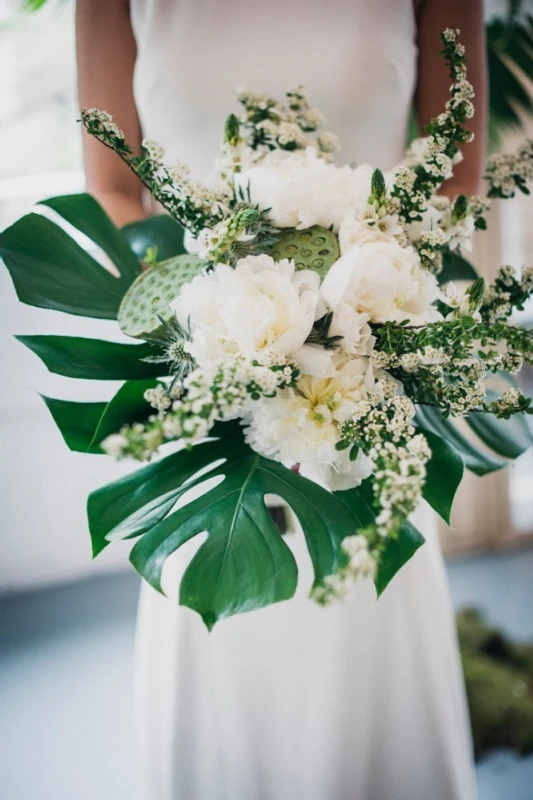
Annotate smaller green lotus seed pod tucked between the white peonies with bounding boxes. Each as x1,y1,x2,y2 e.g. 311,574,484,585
269,225,340,280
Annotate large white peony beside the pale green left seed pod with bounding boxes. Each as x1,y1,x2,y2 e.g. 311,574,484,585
171,255,321,369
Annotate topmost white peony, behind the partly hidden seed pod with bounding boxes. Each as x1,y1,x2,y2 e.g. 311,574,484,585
235,147,372,231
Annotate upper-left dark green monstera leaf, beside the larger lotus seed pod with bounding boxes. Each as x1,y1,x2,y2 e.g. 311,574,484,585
0,195,140,319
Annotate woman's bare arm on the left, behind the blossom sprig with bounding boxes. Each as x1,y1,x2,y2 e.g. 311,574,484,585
76,0,147,225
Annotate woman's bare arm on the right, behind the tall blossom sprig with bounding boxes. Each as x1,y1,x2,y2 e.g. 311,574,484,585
415,0,487,197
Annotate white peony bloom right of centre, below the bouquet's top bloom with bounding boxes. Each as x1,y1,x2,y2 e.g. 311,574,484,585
321,240,440,328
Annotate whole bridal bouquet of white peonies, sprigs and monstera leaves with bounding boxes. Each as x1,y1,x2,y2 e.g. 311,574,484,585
0,30,533,627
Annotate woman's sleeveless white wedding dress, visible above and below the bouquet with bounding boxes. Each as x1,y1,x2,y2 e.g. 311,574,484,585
131,0,475,800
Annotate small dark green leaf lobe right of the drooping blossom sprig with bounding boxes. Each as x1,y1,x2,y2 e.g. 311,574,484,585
419,428,465,525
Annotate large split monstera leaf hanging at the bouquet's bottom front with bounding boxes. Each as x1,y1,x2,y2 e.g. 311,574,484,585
88,423,423,628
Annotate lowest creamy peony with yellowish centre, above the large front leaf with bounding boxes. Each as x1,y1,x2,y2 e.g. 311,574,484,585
246,353,380,489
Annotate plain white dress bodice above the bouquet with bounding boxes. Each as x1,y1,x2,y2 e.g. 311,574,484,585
131,0,416,177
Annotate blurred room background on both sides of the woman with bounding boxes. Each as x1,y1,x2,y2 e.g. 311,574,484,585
0,0,533,800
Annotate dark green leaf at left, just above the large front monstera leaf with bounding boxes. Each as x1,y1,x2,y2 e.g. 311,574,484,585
41,380,157,454
